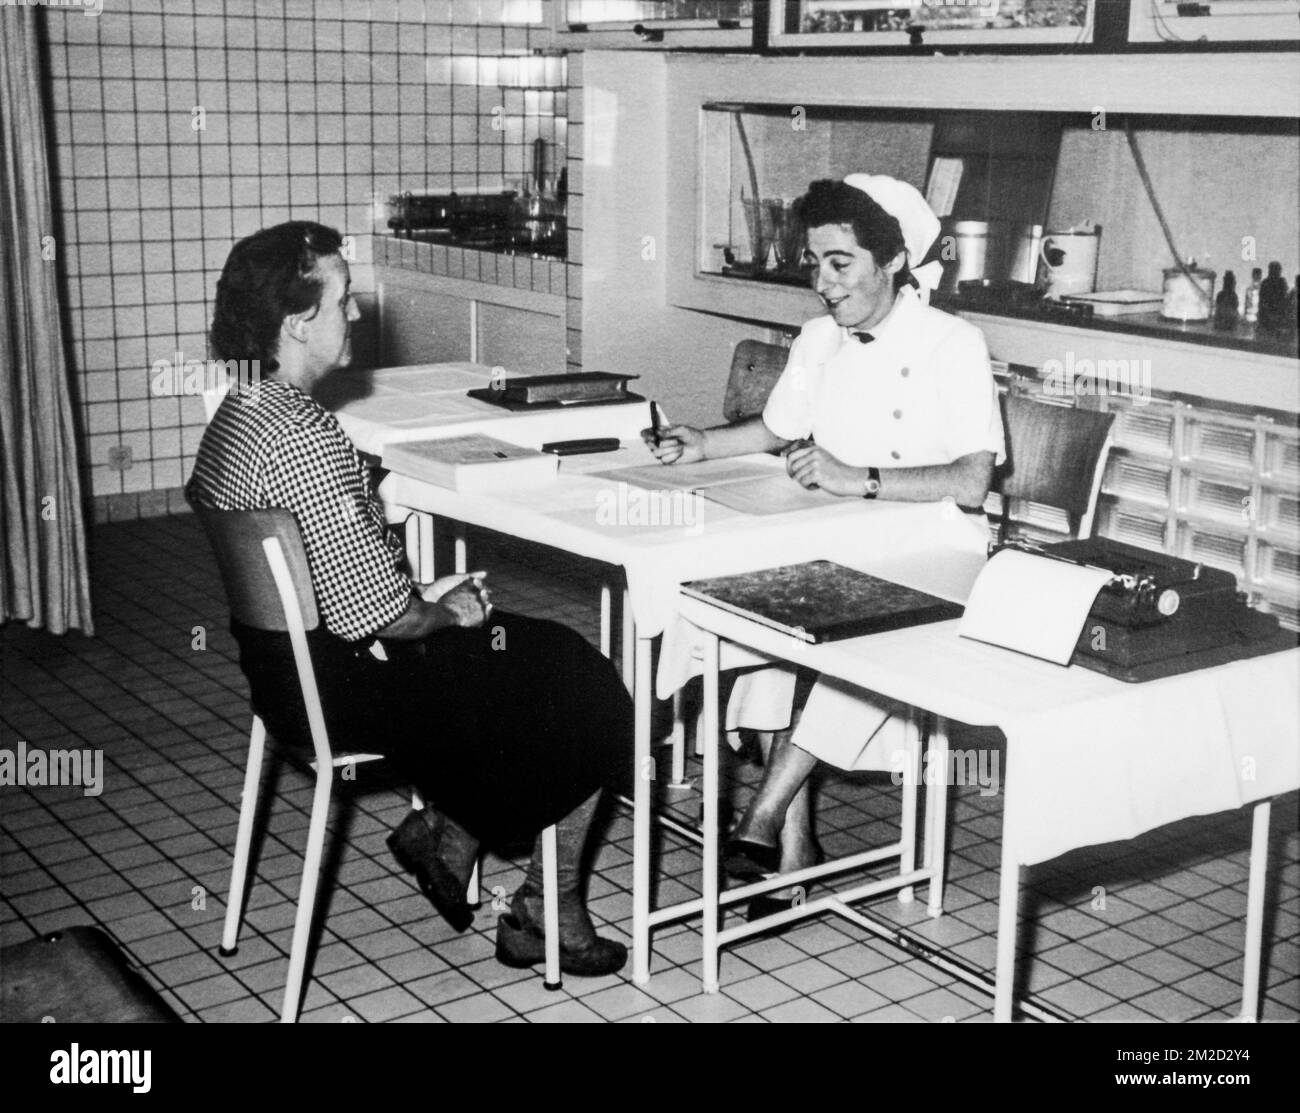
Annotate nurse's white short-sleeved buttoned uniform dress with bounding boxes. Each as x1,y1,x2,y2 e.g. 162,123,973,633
727,287,1005,770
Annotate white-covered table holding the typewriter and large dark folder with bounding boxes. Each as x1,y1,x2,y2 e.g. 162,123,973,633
680,587,1300,1021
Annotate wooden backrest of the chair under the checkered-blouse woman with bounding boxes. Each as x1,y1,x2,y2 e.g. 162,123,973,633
194,506,320,632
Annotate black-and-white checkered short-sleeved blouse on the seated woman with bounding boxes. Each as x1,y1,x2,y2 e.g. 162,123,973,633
186,378,411,641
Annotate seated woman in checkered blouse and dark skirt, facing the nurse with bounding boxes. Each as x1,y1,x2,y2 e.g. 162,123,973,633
187,221,632,975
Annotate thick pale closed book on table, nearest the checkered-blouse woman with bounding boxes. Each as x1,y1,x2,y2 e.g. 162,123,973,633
384,433,559,490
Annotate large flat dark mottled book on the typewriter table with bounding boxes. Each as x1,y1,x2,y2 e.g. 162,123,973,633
681,560,962,644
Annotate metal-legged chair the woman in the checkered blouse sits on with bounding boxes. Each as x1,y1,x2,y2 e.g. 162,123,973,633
195,506,560,1023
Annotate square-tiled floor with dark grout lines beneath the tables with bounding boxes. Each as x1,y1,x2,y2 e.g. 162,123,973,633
0,516,1300,1022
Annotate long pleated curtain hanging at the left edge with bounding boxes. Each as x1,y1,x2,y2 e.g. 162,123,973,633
0,5,94,635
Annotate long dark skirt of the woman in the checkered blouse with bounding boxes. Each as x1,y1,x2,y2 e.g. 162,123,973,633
233,611,632,844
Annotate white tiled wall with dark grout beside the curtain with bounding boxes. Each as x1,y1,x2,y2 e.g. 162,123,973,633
42,0,563,506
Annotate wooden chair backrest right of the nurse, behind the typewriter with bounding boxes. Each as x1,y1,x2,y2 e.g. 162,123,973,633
998,393,1115,537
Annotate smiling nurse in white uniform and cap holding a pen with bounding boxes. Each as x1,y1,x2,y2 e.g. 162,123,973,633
653,174,1004,879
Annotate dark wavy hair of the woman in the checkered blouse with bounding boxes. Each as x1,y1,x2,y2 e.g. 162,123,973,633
208,220,343,374
